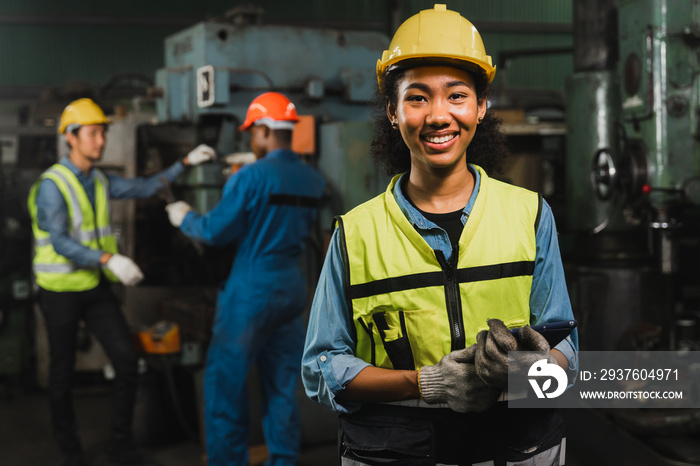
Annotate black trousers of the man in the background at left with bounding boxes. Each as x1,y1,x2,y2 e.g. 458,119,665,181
39,280,138,454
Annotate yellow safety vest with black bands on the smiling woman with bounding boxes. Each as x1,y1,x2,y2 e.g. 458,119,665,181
338,167,541,369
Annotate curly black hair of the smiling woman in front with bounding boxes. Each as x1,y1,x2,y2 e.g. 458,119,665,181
370,67,509,176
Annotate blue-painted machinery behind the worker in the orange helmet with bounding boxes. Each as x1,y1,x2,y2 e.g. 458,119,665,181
156,10,389,221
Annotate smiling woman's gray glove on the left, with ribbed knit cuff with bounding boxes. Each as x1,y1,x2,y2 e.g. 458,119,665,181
418,345,501,413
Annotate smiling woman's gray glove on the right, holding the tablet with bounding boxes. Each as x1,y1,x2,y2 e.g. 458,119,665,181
475,319,556,389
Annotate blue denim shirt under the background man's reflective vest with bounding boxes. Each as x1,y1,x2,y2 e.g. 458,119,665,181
36,157,185,268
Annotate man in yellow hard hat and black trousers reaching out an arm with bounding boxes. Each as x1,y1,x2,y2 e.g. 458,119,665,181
28,99,215,466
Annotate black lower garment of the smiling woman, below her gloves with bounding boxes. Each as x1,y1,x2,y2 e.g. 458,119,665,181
339,402,565,466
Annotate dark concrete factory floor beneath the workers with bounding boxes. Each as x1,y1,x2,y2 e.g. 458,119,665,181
0,374,628,466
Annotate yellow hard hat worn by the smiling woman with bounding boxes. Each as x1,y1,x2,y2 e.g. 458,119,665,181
377,4,496,89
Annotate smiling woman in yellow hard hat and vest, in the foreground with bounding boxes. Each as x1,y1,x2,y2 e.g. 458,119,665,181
302,4,578,466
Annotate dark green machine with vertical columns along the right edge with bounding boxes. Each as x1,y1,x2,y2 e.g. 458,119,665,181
564,0,700,465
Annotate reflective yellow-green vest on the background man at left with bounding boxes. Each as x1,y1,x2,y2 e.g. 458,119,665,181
28,164,119,291
